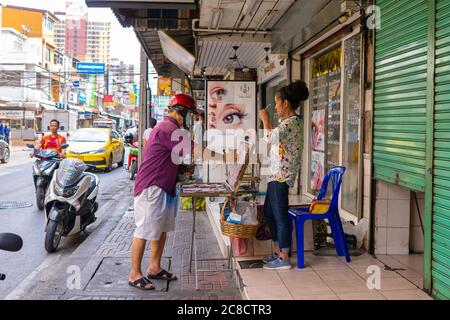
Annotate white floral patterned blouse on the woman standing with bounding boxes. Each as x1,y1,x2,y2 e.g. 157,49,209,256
267,116,303,187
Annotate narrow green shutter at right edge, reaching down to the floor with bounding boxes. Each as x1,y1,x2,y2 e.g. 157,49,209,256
431,0,450,299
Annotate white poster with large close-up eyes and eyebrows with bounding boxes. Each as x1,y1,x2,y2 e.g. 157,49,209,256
206,80,257,182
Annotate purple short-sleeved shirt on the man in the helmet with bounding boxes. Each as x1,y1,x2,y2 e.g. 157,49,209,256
134,117,194,196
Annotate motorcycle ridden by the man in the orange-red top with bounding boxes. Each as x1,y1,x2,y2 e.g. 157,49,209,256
27,144,69,210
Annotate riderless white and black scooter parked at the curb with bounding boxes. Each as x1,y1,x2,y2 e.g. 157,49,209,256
45,158,99,253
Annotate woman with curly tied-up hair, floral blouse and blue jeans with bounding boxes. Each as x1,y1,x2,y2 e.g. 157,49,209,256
259,81,309,270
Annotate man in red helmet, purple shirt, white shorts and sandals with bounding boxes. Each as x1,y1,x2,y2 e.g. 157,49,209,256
128,94,201,290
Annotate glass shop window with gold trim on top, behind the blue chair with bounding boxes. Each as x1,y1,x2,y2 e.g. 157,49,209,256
308,46,342,194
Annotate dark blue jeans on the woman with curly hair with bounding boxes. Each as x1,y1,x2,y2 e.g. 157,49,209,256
264,181,291,253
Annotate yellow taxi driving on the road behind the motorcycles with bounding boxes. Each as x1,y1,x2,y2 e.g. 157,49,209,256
66,128,125,171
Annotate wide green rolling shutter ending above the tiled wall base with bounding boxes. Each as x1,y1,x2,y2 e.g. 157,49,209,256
373,0,428,191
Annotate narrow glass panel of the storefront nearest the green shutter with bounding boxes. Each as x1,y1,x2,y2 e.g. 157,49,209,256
341,34,361,214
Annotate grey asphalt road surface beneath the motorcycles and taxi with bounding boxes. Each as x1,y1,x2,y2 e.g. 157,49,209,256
0,148,128,299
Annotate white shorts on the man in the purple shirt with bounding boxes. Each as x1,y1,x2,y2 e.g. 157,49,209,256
134,186,178,241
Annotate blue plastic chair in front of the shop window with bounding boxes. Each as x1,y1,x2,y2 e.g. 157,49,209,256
289,167,350,269
